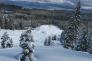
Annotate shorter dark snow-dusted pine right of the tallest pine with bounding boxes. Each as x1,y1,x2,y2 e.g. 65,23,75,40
76,30,89,52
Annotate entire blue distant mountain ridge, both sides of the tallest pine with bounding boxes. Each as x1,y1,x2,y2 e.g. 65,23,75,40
0,0,92,12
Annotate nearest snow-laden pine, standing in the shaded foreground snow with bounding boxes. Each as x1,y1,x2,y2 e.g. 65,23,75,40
20,29,34,61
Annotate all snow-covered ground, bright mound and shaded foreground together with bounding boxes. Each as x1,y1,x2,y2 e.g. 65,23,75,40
0,25,92,61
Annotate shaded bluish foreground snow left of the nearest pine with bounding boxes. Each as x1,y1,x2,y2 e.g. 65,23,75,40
0,47,22,61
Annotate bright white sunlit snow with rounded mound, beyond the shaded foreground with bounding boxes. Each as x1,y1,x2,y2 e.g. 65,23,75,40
0,25,62,46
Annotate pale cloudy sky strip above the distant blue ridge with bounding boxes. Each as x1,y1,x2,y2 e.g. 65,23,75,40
0,0,92,7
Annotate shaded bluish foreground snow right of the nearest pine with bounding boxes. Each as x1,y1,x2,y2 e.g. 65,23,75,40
35,47,92,61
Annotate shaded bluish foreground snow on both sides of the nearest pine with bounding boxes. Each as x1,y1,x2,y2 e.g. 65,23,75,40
0,46,92,61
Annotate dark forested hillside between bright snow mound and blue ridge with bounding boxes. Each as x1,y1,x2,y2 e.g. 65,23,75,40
0,4,92,29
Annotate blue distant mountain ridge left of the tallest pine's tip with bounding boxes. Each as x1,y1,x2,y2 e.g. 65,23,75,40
1,1,73,10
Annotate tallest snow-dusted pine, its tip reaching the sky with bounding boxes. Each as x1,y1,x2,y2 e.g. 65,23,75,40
64,0,81,49
